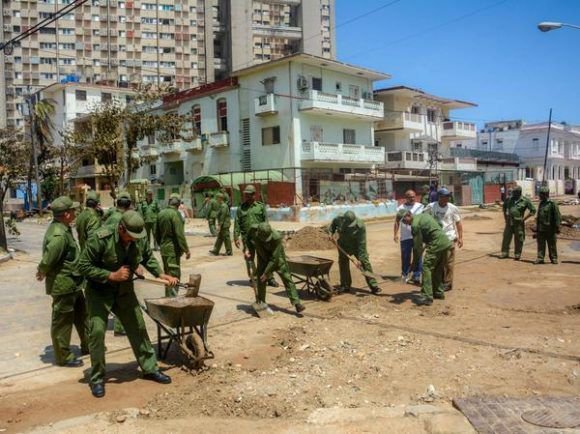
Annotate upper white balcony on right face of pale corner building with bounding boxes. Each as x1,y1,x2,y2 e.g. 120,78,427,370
299,90,384,120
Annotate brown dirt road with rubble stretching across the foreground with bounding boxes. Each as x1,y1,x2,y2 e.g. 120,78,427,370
0,207,580,432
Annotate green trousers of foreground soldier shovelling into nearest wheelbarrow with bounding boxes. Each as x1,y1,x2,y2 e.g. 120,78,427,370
86,287,157,384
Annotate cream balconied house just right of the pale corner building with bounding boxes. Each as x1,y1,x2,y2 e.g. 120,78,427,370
375,86,477,170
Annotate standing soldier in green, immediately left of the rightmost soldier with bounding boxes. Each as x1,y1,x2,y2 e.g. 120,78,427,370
501,186,536,261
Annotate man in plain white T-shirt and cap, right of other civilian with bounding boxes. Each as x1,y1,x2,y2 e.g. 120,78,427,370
425,188,463,291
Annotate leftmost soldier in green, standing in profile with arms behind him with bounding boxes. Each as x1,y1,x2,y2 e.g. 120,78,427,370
36,196,89,367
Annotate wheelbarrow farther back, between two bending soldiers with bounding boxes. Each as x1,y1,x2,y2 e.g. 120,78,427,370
287,255,335,301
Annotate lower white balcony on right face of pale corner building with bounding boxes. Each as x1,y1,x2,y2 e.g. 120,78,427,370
301,142,385,164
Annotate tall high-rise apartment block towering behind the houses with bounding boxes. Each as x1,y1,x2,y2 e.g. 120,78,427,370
0,0,335,126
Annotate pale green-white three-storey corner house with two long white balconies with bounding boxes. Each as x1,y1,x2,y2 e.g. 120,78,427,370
135,54,389,202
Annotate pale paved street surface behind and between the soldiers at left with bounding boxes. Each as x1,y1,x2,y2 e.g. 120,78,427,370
0,220,312,378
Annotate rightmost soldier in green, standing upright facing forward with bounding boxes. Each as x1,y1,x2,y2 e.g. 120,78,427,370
534,187,561,264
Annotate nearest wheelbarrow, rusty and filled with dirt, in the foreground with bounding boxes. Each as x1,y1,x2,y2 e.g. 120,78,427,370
144,296,214,369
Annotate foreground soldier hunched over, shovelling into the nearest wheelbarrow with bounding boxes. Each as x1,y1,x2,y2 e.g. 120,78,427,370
79,210,177,398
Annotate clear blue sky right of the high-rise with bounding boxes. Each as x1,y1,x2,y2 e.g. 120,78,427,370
336,0,580,126
